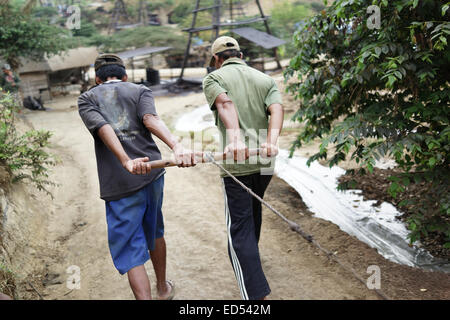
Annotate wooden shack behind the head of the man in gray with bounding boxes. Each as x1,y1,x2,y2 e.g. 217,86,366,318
18,47,98,101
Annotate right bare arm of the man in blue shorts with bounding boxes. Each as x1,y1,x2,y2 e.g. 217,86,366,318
143,114,196,167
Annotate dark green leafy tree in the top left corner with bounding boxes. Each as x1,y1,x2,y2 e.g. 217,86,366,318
0,5,65,68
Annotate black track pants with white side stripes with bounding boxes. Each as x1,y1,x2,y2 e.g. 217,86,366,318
223,173,272,300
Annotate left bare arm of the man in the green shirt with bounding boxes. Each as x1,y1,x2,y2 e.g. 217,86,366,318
215,93,248,161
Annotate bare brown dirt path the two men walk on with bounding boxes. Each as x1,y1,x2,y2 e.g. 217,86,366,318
22,94,450,299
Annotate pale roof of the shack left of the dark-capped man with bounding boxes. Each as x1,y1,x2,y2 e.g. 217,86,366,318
19,47,98,73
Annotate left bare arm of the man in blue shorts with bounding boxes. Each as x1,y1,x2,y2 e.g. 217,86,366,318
97,124,151,174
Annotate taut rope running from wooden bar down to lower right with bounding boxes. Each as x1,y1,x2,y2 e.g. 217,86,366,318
206,153,391,300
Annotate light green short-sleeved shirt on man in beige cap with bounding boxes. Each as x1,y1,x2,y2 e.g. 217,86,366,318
203,58,282,176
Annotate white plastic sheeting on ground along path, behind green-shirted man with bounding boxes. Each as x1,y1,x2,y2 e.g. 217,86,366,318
175,105,450,272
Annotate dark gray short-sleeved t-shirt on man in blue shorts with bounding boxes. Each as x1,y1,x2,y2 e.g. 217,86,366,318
78,81,165,201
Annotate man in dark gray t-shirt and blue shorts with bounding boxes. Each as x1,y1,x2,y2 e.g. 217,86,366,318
78,54,195,299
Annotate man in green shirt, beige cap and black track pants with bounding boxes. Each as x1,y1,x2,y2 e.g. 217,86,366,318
203,37,283,300
